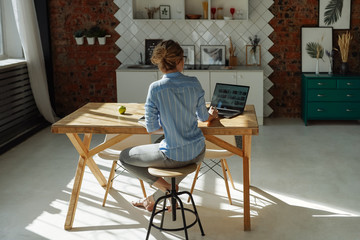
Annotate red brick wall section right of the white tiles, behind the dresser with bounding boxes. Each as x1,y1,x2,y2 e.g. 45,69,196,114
269,0,360,118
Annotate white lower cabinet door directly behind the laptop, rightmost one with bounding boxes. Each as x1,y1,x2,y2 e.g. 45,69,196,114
236,71,264,124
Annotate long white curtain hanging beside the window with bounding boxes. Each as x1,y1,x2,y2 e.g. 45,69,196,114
12,0,58,123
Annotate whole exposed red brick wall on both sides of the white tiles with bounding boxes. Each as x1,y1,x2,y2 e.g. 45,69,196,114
49,0,360,117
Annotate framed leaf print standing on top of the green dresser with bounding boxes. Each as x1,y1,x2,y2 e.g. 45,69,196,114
301,27,333,72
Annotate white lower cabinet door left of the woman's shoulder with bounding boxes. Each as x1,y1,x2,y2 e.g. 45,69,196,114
116,71,158,103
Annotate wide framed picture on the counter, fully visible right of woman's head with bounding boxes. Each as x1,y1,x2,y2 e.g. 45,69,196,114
200,45,226,65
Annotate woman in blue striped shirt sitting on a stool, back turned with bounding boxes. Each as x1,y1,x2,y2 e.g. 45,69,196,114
120,40,217,211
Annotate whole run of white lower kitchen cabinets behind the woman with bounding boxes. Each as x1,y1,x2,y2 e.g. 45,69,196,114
116,66,264,125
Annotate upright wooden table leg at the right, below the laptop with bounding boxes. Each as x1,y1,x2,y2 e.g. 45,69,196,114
243,135,251,231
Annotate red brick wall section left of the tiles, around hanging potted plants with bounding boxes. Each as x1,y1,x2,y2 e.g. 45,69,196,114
49,0,120,116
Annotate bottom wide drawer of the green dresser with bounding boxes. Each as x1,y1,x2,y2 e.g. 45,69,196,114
308,102,360,119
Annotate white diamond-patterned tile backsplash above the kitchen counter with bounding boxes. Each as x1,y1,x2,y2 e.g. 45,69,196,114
114,0,274,116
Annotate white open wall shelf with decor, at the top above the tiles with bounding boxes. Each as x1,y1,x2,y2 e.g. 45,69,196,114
132,0,249,21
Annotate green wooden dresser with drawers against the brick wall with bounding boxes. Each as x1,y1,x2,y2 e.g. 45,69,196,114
302,74,360,125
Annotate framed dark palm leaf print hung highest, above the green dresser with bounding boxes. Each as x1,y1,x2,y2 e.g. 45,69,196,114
319,0,351,29
